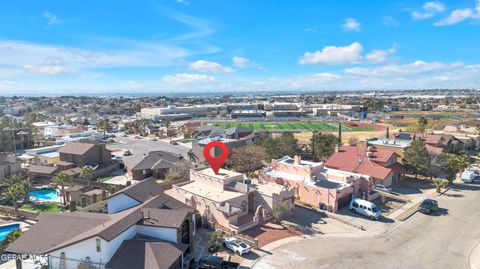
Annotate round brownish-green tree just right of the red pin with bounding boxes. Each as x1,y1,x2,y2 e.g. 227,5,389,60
226,145,266,177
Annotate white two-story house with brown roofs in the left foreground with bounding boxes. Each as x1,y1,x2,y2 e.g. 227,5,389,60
7,179,195,269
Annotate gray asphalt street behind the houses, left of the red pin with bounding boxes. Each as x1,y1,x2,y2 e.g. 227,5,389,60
107,137,189,158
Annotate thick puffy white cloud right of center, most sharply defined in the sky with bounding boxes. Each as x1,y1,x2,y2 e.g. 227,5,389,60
300,42,363,65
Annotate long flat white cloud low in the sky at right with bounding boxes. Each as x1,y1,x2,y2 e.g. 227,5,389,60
345,60,463,76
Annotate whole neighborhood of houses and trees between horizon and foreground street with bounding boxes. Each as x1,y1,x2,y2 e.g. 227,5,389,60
0,92,480,269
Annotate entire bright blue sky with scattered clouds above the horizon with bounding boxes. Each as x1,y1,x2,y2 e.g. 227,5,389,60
0,0,480,94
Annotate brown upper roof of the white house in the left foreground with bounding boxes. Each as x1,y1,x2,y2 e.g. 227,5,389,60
8,180,193,254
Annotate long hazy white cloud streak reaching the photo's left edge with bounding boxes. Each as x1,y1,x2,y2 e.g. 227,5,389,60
0,40,193,69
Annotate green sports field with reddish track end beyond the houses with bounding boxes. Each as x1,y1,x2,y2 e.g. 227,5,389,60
208,121,375,132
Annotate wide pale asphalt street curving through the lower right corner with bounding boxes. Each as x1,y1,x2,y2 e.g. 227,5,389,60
253,184,480,269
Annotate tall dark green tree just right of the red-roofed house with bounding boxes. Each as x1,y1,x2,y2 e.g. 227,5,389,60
403,140,431,179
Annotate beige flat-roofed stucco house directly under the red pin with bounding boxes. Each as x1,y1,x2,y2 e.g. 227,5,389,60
171,168,295,232
